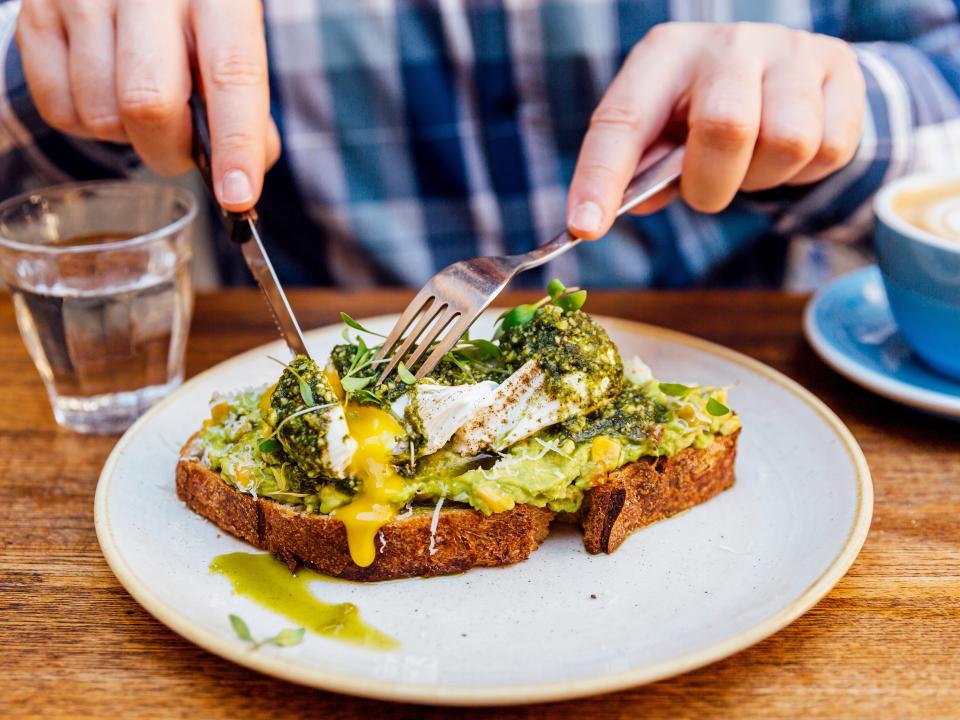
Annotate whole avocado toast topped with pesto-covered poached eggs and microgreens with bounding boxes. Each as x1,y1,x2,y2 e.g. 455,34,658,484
177,282,739,580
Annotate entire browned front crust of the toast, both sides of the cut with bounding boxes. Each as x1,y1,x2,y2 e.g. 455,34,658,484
176,431,739,581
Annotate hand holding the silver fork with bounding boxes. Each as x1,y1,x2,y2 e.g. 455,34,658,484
567,23,865,239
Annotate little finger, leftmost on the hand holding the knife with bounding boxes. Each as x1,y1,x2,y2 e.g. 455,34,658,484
16,2,87,137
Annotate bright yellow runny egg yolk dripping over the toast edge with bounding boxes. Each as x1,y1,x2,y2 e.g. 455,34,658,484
330,405,404,567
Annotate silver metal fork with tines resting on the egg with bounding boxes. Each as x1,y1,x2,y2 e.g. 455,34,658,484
373,145,684,385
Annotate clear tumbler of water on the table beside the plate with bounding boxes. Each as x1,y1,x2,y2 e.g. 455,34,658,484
0,181,197,433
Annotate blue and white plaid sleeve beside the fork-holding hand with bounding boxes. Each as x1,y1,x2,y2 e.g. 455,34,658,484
760,3,960,241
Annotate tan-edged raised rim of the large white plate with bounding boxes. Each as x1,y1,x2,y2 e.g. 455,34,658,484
94,314,873,706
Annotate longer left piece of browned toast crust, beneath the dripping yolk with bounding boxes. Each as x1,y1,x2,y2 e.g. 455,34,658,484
177,456,555,580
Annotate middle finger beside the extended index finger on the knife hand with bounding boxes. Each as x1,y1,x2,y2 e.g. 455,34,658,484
117,0,193,175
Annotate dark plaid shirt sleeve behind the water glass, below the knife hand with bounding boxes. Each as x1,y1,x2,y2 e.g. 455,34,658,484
0,2,139,198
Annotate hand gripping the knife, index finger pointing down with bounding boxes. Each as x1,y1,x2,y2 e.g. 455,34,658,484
16,0,280,211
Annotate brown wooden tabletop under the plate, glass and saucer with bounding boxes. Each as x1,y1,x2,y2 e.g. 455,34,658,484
0,290,960,718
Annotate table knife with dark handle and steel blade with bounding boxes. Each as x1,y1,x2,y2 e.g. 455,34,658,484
190,88,310,357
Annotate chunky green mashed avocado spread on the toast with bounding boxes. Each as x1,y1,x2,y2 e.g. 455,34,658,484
191,372,740,515
